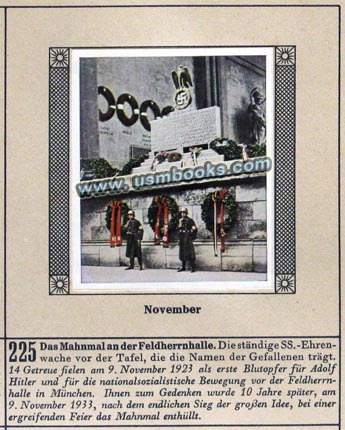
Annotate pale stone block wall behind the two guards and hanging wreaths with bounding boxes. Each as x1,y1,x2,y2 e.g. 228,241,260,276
81,175,267,272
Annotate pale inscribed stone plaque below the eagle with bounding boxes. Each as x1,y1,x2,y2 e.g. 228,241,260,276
151,106,221,152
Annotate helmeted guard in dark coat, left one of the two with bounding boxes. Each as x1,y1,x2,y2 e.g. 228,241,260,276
123,210,144,270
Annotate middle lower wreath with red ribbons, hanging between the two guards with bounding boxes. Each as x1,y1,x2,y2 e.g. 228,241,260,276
148,195,179,247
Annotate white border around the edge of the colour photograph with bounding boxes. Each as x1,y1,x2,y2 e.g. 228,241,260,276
49,46,295,295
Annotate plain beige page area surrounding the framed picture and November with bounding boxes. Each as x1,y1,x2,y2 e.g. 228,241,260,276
0,1,339,337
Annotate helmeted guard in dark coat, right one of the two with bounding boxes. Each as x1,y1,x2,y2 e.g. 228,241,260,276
178,208,198,273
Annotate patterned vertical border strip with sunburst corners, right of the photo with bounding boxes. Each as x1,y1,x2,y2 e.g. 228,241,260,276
274,46,296,294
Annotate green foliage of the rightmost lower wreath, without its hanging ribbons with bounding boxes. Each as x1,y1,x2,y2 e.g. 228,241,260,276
201,191,238,233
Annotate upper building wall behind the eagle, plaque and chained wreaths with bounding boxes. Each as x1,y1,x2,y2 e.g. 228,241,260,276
80,56,266,168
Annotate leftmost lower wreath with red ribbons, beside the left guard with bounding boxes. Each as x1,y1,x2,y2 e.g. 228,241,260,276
105,200,129,248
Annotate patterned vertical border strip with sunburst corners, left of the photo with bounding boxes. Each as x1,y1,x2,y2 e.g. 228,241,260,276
49,48,70,295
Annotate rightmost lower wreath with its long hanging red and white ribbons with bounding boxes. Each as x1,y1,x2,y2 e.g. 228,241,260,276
201,189,238,256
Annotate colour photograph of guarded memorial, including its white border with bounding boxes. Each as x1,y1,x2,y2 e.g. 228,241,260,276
69,48,274,292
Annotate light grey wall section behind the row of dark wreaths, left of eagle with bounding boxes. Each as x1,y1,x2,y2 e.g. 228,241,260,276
97,57,196,168
